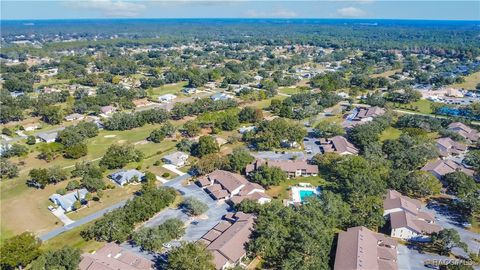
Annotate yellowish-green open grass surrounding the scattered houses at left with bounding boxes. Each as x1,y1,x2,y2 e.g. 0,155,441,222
0,125,176,241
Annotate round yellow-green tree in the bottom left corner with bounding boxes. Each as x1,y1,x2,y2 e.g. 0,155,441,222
0,232,41,269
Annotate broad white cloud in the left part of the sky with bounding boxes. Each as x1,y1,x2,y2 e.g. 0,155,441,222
73,0,145,17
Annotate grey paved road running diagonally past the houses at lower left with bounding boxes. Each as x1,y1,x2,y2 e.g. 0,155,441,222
39,174,191,241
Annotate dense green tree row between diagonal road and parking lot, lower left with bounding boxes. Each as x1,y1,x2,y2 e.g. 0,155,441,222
80,187,176,243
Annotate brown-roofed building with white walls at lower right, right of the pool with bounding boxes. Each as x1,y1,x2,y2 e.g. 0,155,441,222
383,190,442,241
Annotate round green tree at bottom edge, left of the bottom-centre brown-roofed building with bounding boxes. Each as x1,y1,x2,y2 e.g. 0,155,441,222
165,242,215,270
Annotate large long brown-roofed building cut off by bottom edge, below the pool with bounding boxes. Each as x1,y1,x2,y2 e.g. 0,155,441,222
333,226,398,270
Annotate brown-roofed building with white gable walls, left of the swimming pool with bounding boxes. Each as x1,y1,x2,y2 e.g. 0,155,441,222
196,170,270,204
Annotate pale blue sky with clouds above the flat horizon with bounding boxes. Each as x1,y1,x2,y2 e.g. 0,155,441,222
0,0,480,20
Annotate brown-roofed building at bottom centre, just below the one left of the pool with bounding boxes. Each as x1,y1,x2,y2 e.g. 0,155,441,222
199,212,255,270
